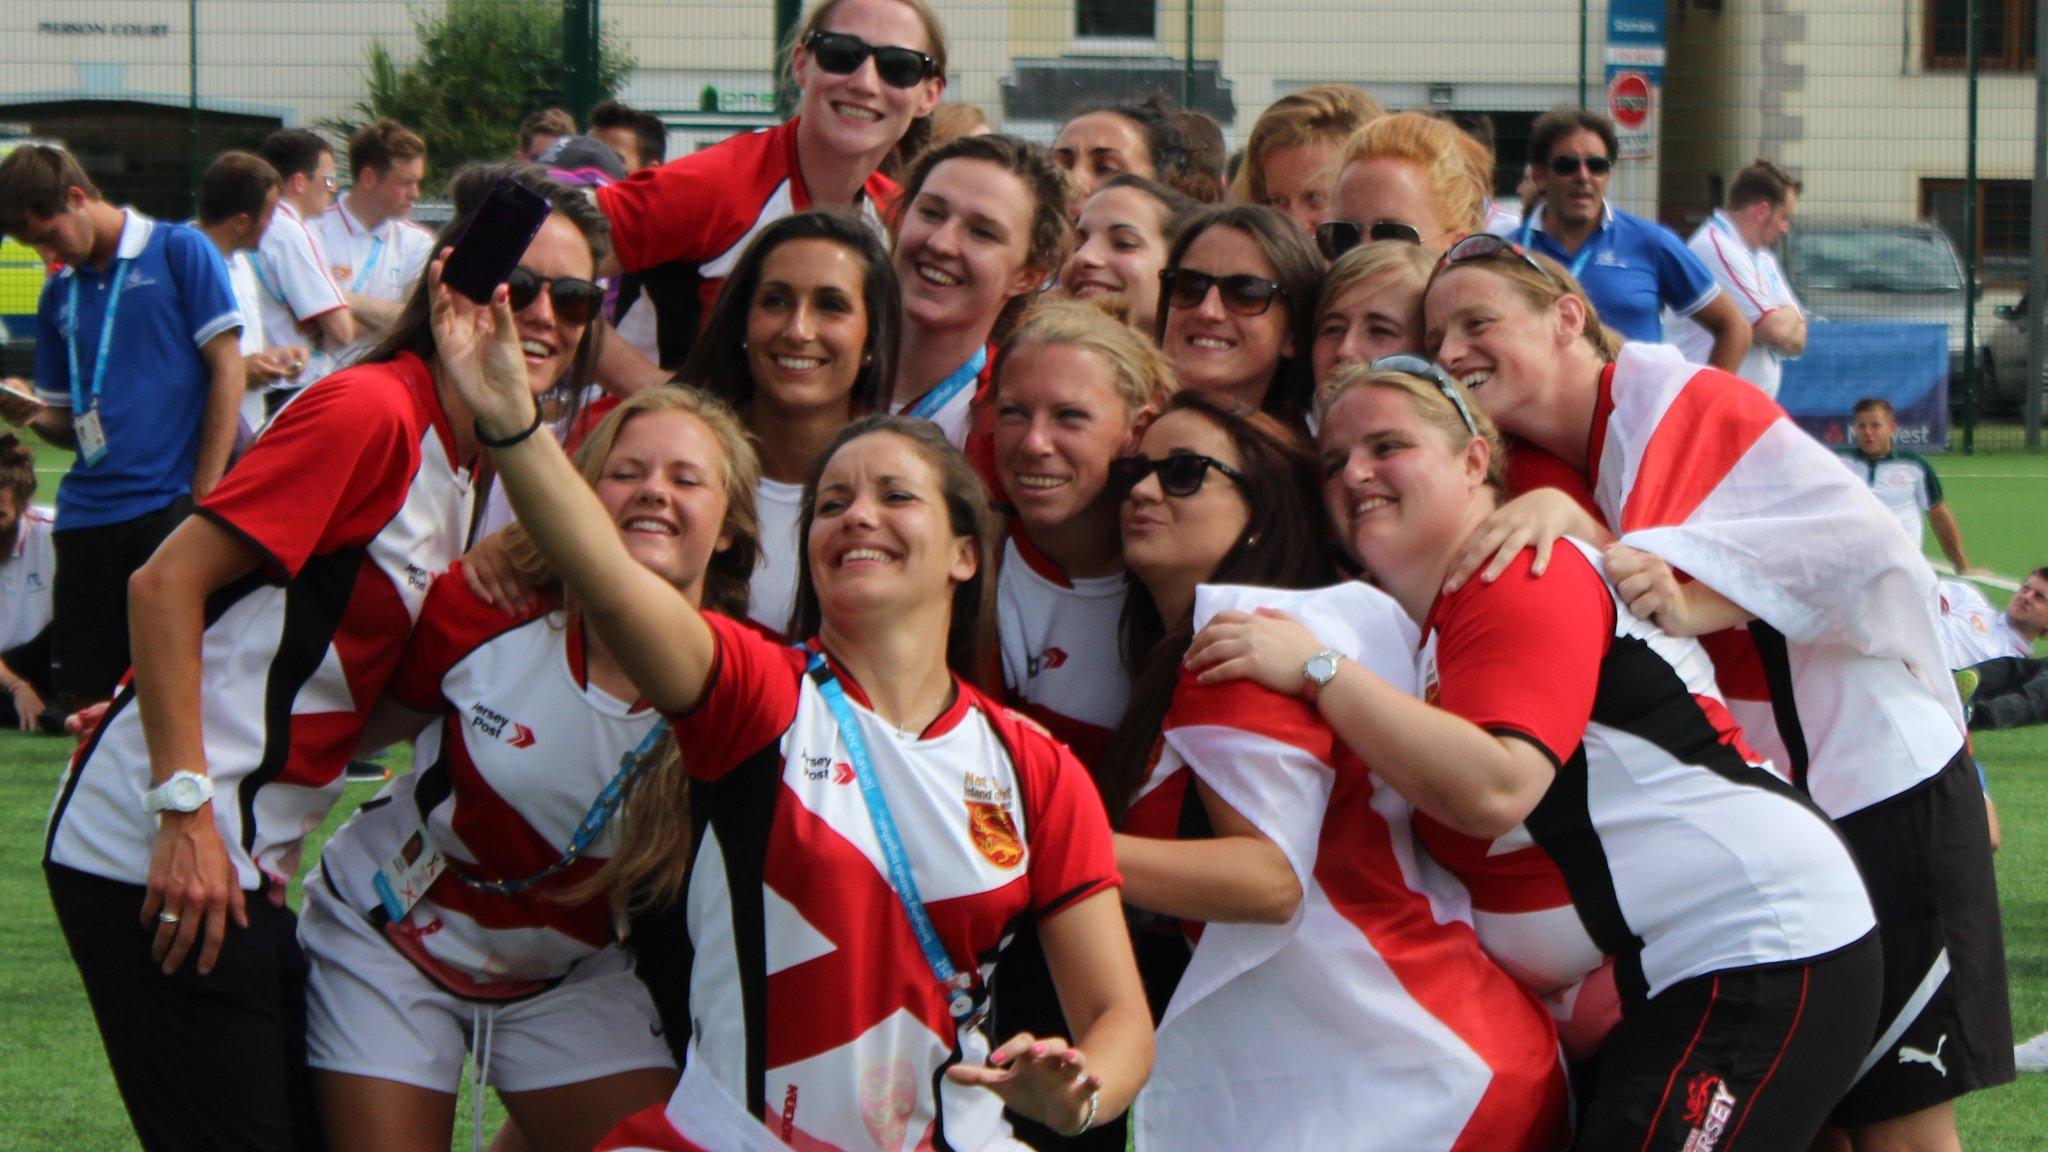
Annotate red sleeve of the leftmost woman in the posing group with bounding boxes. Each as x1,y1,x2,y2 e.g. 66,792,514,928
199,361,428,578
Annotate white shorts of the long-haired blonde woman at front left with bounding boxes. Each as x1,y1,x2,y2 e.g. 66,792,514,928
299,873,676,1095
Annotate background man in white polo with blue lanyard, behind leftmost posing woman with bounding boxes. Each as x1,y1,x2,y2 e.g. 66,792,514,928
307,119,434,362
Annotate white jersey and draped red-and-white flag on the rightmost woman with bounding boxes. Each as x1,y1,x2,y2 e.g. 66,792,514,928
1587,344,1964,820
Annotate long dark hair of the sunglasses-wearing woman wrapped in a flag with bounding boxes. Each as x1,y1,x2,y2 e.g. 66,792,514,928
1090,393,1337,822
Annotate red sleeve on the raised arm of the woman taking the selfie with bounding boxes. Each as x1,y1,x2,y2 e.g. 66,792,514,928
668,613,805,779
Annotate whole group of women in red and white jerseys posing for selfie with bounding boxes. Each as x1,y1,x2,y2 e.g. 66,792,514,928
47,0,2011,1152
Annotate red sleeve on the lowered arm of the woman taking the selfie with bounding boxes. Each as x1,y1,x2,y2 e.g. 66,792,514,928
1003,703,1122,920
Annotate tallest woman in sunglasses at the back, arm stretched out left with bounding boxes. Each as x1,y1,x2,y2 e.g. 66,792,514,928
598,0,946,379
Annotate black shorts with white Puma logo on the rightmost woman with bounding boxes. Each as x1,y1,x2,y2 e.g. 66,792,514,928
1833,752,2013,1127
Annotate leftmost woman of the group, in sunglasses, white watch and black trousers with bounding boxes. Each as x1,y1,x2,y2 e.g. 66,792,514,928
45,164,606,1148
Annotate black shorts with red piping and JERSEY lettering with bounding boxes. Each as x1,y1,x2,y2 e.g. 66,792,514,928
1573,935,1882,1152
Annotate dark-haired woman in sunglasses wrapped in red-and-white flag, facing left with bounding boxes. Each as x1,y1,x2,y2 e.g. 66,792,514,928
1102,389,1565,1152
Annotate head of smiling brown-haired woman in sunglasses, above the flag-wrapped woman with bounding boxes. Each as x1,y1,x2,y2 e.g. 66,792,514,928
1157,205,1323,424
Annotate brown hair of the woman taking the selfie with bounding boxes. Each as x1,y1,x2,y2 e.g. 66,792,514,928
791,412,1001,691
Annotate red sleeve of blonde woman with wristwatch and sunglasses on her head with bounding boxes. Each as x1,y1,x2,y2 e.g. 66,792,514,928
1436,543,1614,763
